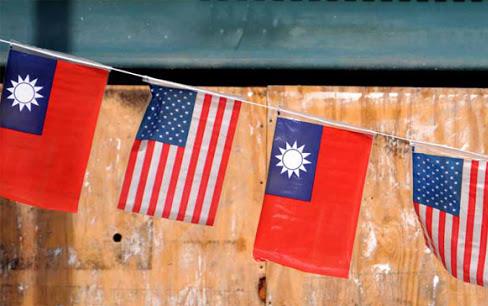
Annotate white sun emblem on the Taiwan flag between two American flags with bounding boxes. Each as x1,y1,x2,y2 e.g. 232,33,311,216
275,141,311,178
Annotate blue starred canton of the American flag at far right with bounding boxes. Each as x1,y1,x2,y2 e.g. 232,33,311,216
413,153,463,216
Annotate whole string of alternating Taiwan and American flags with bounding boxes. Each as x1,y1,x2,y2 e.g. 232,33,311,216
0,39,488,286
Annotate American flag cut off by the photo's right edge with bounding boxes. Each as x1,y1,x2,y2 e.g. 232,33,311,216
413,152,488,286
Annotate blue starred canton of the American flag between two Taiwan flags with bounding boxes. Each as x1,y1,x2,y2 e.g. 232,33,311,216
136,85,197,147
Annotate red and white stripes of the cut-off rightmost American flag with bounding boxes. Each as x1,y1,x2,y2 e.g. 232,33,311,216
414,160,488,286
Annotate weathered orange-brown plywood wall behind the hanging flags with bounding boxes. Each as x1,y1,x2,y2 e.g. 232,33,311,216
0,86,488,306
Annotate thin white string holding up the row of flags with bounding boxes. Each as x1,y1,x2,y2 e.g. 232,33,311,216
0,38,488,159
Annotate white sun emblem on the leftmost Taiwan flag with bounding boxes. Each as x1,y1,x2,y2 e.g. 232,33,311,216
7,75,43,111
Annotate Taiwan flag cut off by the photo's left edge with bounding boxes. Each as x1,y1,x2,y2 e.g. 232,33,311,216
0,49,108,212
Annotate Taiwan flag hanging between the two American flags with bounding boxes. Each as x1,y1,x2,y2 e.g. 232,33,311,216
254,118,373,278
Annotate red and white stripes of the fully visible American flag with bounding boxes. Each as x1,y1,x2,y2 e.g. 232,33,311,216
118,93,241,225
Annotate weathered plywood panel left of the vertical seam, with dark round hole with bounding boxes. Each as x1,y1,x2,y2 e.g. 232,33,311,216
0,86,266,305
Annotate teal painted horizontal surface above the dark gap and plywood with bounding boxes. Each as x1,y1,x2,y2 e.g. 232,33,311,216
0,0,488,69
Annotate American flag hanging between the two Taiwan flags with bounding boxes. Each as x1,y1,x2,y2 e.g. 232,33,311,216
118,85,241,225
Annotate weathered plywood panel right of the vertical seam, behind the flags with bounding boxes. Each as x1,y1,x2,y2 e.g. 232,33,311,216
266,86,488,305
